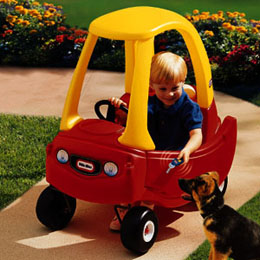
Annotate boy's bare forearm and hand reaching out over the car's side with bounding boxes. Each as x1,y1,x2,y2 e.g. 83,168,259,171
178,128,202,163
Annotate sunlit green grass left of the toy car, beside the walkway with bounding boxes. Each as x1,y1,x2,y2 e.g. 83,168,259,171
0,114,59,209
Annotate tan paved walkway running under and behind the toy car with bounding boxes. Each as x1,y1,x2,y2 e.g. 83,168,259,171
0,68,260,260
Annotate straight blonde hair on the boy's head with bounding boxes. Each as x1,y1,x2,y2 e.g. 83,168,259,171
150,52,187,84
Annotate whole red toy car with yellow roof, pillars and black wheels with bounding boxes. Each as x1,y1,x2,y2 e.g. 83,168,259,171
36,7,237,253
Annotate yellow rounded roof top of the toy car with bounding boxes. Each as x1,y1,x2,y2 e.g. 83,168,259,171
89,6,190,40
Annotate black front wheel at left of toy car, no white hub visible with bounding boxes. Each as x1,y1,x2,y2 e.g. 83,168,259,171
36,186,76,230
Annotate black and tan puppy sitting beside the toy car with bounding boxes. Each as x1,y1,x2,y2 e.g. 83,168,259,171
179,172,260,260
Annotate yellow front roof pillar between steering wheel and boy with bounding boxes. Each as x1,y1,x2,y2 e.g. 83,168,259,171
118,37,155,150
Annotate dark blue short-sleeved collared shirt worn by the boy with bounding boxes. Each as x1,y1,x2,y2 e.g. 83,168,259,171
148,90,203,150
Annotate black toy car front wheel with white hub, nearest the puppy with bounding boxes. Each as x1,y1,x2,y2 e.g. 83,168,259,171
121,207,158,254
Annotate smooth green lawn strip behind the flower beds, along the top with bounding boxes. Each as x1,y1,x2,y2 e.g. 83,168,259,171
39,0,260,28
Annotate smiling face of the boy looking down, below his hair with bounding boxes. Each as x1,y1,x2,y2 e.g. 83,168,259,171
151,82,184,108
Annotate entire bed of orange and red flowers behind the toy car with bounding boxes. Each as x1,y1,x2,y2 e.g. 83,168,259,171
0,0,260,88
